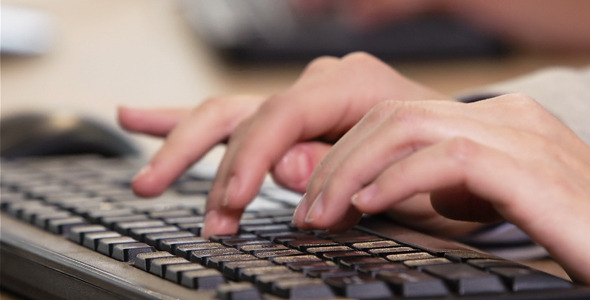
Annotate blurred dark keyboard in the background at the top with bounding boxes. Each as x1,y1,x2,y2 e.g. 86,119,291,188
179,0,506,62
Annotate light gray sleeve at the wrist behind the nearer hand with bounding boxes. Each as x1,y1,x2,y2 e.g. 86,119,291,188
466,67,590,144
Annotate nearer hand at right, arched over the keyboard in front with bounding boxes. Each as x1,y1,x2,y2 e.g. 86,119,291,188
294,95,590,283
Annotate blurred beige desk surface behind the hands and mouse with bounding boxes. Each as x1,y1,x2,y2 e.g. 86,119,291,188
1,0,590,284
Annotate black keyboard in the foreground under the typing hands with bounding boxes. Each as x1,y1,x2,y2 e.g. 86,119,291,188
0,156,590,300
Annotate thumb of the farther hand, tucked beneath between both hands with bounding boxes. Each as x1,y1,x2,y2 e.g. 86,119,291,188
271,142,332,193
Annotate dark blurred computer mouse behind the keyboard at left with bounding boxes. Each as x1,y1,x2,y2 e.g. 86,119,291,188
0,112,139,158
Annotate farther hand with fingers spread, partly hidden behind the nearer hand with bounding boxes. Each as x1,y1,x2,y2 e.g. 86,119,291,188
119,53,454,236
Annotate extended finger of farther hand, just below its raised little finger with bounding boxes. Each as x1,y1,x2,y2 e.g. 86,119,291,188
133,96,264,196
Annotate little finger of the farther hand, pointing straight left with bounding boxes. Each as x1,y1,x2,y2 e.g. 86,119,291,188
117,106,190,137
